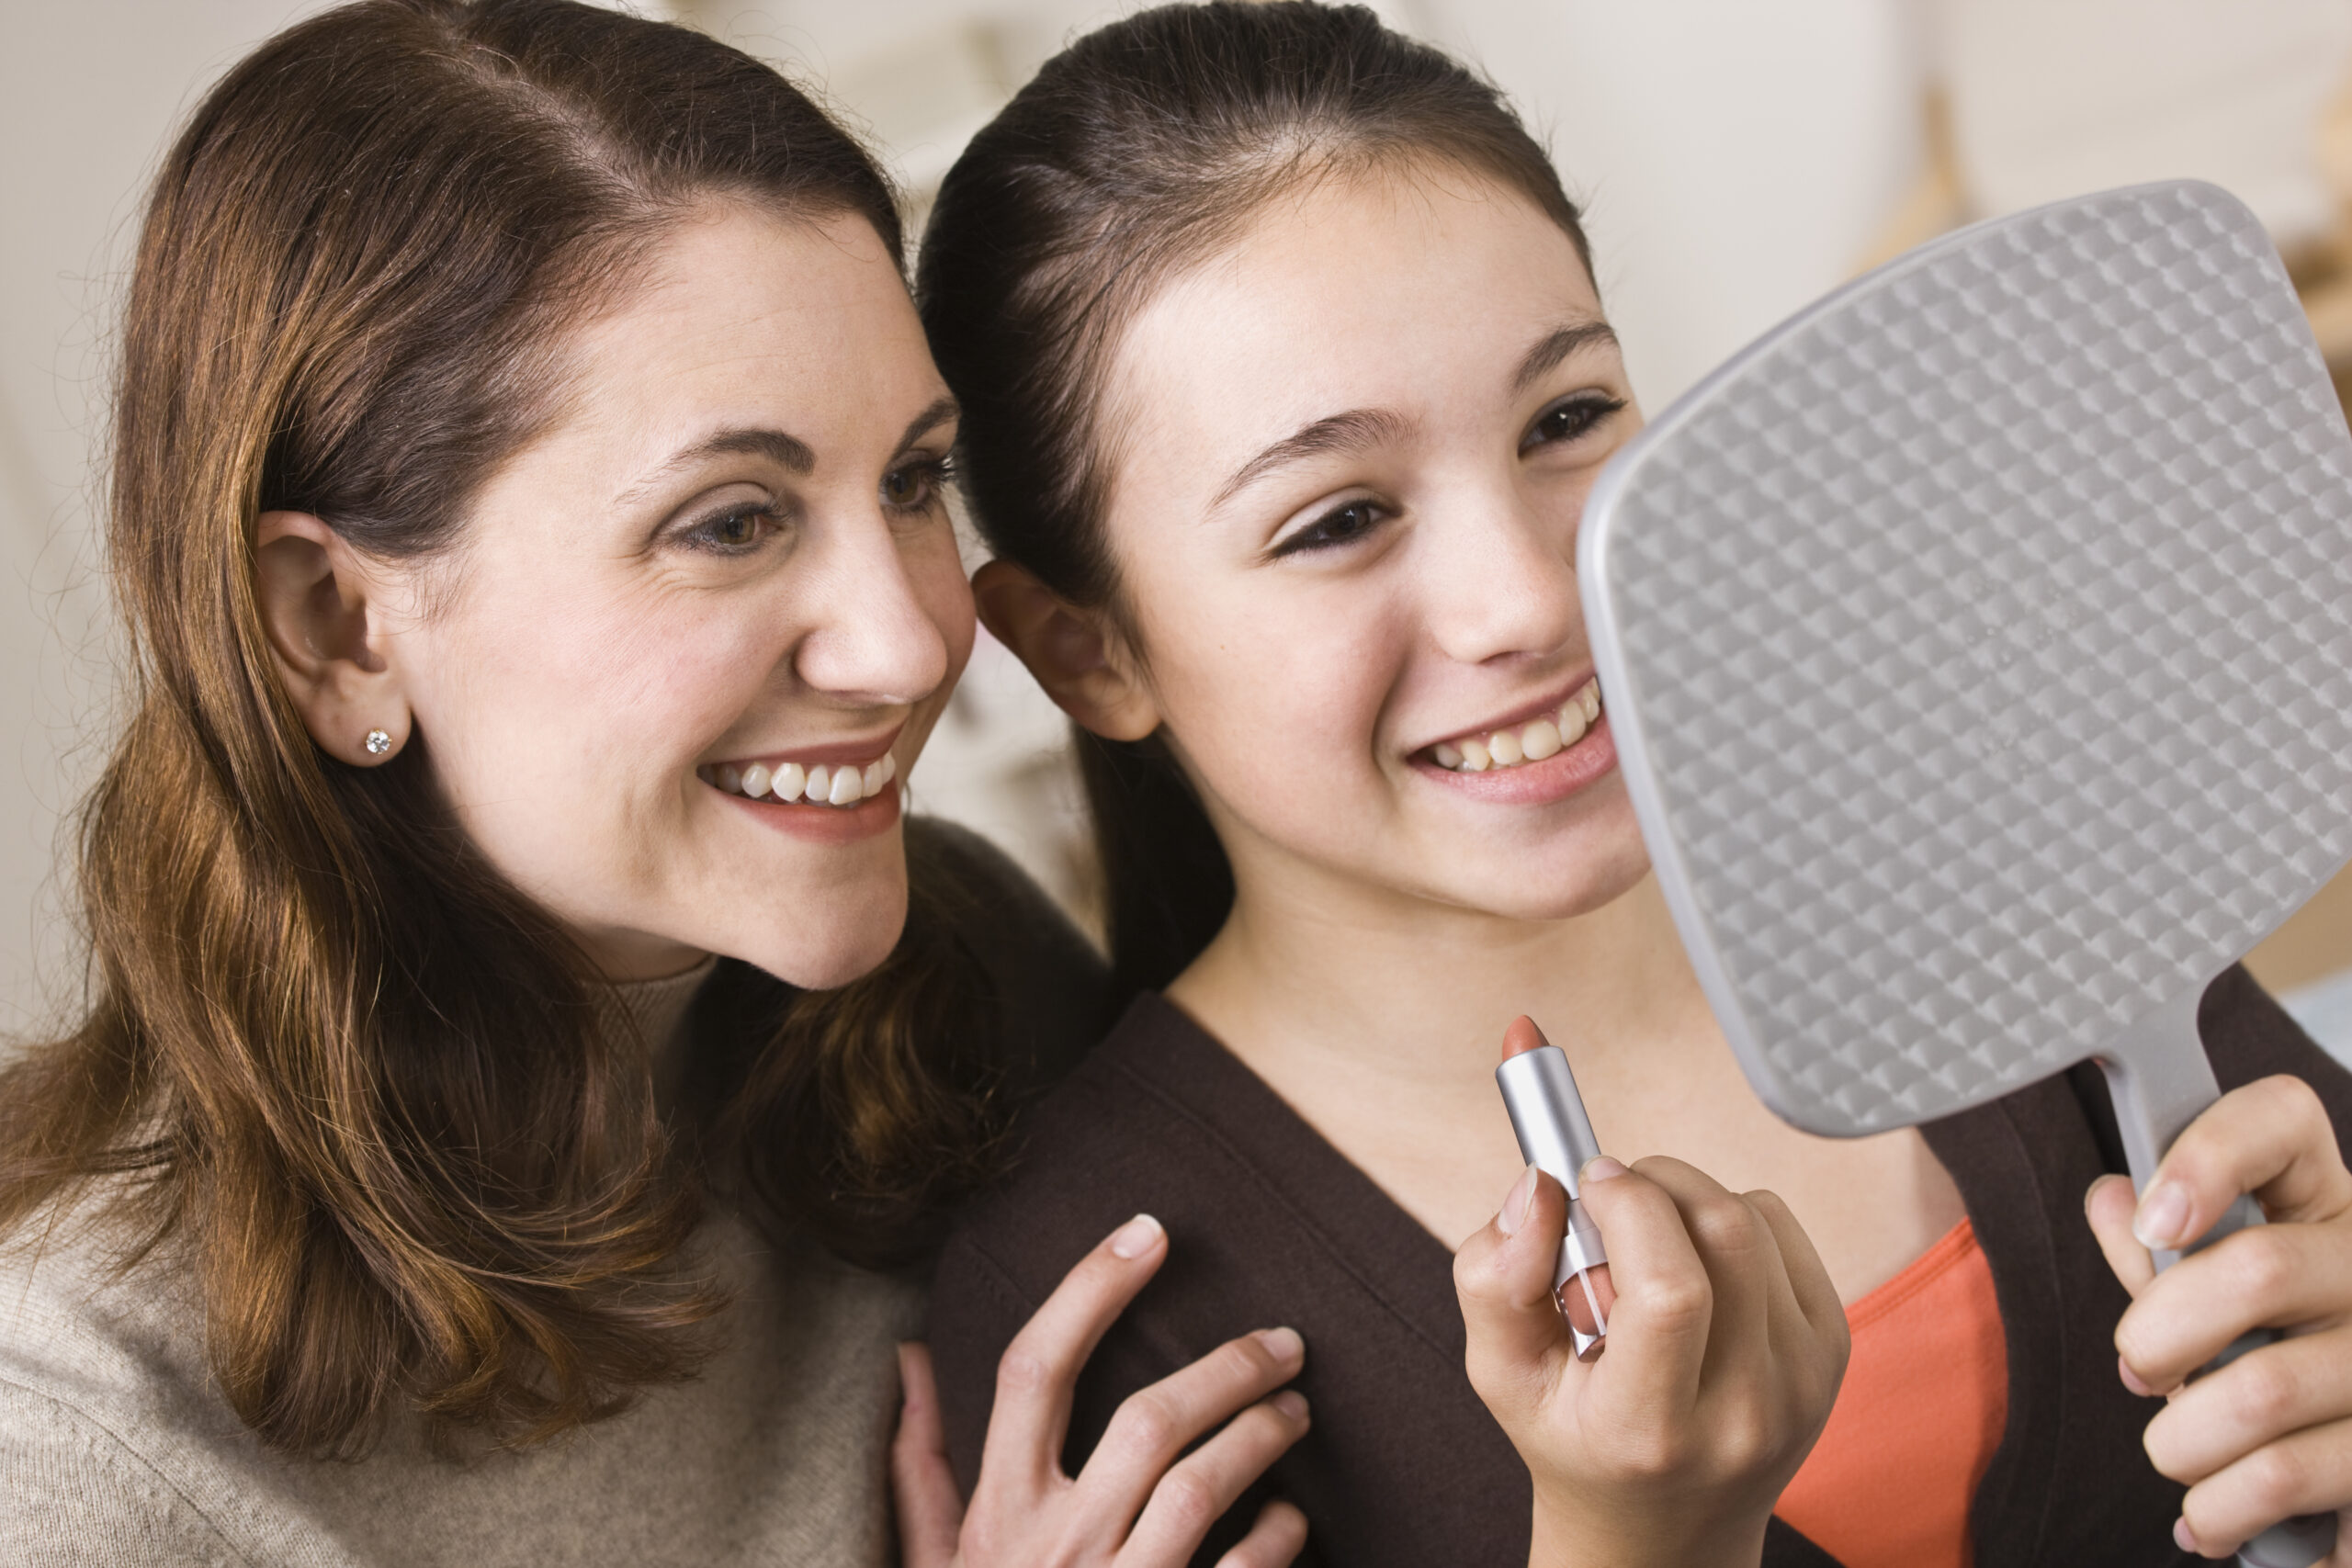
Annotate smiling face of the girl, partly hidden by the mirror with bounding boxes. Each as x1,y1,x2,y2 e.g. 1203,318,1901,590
1105,169,1646,919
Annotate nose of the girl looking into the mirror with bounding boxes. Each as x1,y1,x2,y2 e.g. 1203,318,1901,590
1420,491,1583,665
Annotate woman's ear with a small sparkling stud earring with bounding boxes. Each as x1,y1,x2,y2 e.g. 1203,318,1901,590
254,513,409,766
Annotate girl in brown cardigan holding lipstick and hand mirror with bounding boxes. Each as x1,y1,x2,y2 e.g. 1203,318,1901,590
917,3,2352,1568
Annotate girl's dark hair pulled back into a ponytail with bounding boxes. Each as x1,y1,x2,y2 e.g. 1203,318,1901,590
915,0,1590,989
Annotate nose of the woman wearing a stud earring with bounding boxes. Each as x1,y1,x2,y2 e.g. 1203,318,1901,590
793,517,969,707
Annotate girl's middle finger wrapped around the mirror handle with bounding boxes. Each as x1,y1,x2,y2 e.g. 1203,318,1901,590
2114,1223,2352,1392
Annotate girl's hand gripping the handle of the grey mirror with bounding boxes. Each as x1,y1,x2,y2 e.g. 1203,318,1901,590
2086,1077,2352,1568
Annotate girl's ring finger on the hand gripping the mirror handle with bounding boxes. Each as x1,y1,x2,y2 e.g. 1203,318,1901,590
2145,1328,2352,1481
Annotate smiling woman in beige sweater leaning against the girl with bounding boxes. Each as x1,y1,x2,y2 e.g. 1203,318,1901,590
0,0,1306,1565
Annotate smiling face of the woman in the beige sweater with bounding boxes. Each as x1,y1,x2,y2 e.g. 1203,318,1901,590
388,197,974,985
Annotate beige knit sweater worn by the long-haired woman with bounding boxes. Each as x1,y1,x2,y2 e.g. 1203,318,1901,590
0,966,922,1568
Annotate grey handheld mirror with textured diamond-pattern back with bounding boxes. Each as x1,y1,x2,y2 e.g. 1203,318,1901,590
1578,184,2352,1568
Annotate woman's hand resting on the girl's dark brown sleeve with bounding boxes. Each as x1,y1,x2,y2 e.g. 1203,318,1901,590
891,1215,1307,1568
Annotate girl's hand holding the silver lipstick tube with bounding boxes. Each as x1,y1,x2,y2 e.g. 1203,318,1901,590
1453,1159,1849,1568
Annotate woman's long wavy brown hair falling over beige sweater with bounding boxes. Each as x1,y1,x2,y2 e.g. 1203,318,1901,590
0,0,1021,1453
